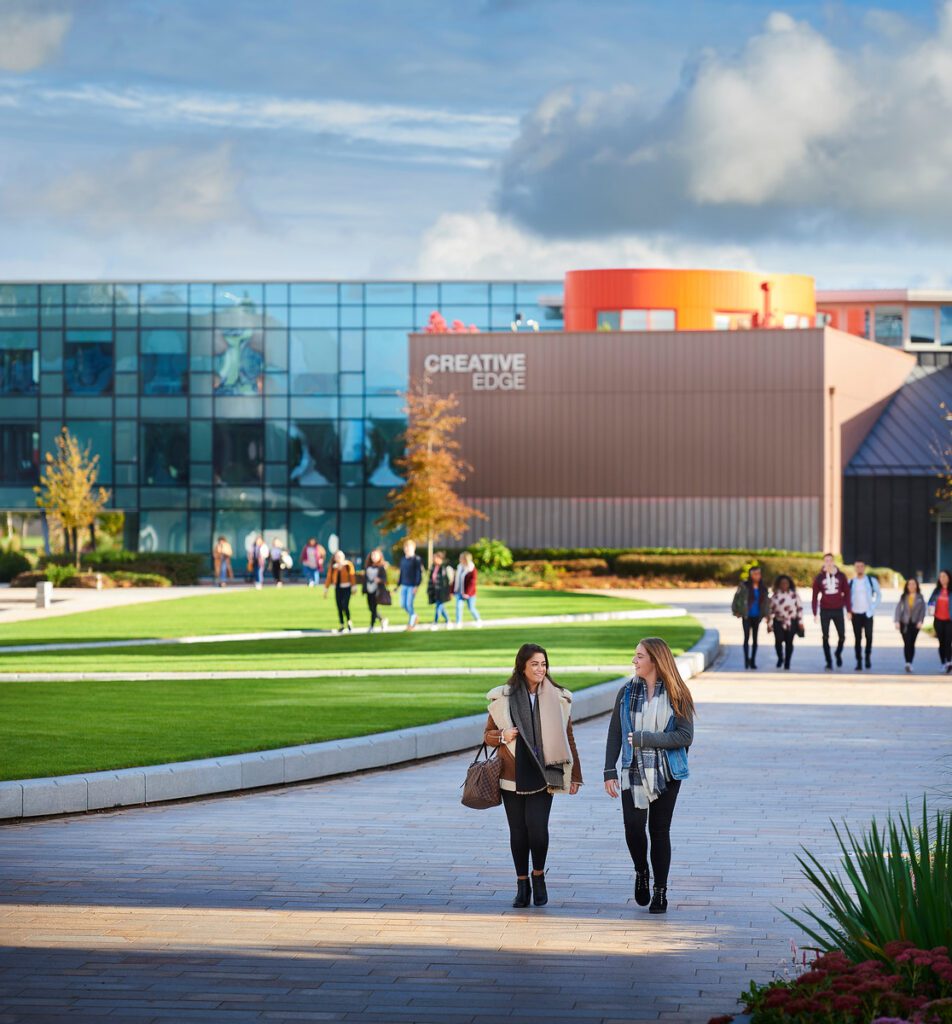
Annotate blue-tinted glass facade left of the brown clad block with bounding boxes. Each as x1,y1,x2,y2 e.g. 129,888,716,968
0,281,562,554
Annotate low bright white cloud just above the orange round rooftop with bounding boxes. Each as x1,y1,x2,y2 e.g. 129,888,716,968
408,211,755,280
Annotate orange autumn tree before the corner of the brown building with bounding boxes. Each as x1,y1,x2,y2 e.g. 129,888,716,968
377,377,486,564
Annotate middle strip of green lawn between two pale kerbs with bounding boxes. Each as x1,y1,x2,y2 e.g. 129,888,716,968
0,616,702,675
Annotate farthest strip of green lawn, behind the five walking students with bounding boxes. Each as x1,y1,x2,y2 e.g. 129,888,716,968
0,587,658,646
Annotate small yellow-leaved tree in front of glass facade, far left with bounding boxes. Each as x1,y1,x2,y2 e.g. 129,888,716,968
34,427,110,568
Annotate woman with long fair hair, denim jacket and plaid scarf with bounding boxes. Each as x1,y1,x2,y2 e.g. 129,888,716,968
605,637,694,913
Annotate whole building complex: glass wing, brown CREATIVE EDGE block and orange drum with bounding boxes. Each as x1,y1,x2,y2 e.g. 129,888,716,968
0,269,952,575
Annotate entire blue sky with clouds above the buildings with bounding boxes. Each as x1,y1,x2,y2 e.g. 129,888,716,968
0,0,952,288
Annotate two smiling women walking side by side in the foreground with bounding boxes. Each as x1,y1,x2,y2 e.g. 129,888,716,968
483,637,695,913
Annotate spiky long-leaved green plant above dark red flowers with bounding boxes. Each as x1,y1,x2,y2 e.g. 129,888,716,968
781,797,952,964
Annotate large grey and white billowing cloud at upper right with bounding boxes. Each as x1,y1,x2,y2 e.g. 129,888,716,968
496,0,952,240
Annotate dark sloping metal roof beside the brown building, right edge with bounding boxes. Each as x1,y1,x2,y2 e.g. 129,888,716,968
846,367,952,476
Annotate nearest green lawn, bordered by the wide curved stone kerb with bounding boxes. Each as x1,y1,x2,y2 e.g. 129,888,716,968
0,673,612,779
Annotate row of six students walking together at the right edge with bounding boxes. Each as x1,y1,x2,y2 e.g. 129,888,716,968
731,553,952,673
